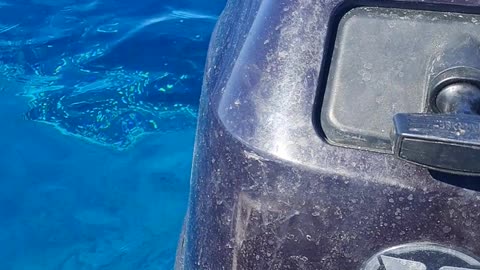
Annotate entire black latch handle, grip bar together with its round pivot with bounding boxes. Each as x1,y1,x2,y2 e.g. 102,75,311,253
393,79,480,176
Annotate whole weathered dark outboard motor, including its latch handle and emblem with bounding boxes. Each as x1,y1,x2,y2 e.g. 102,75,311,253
176,0,480,270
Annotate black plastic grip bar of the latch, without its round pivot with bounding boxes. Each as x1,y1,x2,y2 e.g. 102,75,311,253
393,114,480,176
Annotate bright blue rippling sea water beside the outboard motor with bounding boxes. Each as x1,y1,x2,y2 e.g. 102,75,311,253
0,0,224,270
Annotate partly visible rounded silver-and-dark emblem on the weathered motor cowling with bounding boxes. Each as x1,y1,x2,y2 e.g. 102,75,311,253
361,243,480,270
